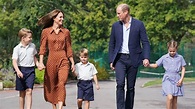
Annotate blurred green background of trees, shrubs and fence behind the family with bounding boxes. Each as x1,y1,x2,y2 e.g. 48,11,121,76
0,0,195,86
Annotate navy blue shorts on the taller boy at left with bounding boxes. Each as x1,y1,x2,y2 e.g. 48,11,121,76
16,66,35,91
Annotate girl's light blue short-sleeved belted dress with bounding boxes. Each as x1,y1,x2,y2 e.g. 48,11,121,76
156,53,186,96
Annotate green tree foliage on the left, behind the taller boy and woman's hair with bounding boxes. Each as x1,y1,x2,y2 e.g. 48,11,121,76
0,0,80,67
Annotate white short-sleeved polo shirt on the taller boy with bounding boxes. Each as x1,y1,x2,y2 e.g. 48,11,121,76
12,43,37,67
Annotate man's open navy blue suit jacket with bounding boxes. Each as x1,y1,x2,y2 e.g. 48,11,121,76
109,18,150,67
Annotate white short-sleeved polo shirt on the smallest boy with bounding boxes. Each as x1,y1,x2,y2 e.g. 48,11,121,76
75,62,98,80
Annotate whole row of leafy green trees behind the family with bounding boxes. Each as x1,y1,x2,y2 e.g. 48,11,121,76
0,0,195,68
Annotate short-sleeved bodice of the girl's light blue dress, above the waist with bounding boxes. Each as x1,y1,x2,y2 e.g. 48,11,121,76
156,53,186,74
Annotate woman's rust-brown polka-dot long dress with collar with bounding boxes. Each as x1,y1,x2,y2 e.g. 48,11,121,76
39,27,73,106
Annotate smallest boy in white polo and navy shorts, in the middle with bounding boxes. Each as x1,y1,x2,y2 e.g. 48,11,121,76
74,48,100,109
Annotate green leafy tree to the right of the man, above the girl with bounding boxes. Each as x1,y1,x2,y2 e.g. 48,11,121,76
125,0,195,45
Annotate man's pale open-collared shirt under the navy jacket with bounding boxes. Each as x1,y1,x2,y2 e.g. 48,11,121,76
120,17,132,54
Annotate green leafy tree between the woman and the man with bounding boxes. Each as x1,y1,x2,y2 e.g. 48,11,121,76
69,0,119,52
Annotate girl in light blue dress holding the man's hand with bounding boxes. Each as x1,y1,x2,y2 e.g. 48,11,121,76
148,40,186,109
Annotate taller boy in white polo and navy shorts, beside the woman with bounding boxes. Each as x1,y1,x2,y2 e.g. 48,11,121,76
12,28,39,109
